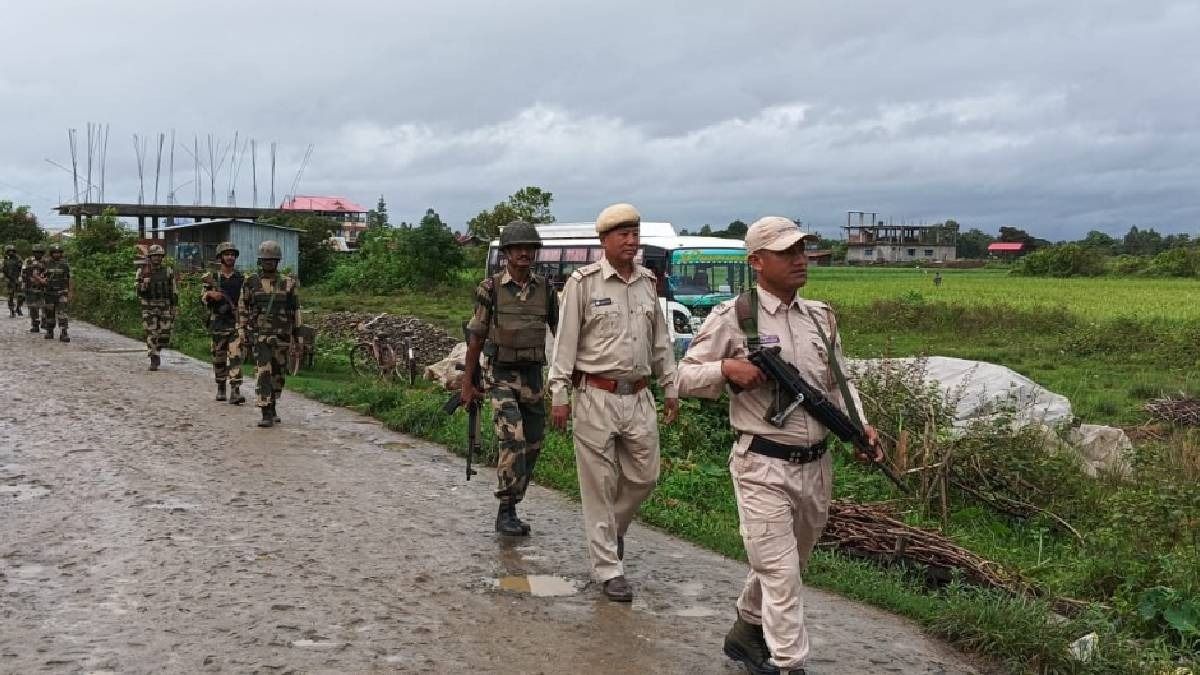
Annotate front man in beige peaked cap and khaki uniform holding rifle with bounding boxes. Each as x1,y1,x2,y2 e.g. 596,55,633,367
679,216,882,674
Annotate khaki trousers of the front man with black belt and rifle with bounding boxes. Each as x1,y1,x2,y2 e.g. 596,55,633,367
730,435,833,669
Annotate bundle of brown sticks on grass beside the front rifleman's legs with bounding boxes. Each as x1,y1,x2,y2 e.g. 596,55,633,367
817,500,1027,592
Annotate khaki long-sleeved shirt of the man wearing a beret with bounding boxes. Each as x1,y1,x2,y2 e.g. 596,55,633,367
550,258,679,406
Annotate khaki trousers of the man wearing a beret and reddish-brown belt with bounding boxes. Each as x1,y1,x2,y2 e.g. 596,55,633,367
574,384,659,583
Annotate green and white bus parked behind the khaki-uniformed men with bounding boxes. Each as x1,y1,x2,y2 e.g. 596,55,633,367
487,222,754,354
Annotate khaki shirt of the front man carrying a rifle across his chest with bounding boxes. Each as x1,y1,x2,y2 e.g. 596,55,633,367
679,287,865,446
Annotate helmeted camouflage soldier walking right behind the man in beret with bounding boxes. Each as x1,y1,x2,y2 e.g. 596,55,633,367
462,221,558,537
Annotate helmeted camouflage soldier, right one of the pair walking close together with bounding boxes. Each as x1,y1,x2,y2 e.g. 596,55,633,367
238,240,300,428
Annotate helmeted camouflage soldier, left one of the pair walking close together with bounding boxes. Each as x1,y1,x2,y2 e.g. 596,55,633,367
200,241,246,405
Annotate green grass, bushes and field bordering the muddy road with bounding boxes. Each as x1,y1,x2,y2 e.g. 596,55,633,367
16,196,1200,674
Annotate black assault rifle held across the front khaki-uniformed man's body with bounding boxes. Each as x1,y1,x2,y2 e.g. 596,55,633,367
749,347,912,494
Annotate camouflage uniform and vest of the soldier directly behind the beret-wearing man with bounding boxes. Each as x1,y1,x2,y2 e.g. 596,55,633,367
467,269,558,506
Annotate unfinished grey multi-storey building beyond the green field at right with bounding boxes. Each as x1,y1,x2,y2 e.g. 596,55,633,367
844,211,959,264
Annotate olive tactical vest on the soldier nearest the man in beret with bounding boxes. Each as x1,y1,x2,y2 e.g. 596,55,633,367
485,271,551,363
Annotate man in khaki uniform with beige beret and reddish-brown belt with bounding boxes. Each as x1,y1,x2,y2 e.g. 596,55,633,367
550,199,679,602
